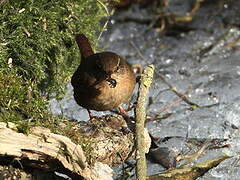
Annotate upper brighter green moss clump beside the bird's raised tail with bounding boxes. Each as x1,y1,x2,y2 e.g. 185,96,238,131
0,0,108,93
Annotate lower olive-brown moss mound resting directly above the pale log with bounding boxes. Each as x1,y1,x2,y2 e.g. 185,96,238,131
0,68,57,133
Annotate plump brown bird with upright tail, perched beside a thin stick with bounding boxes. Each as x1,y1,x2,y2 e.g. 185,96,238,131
71,34,136,118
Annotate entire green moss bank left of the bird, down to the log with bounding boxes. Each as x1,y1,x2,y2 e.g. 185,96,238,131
0,0,110,136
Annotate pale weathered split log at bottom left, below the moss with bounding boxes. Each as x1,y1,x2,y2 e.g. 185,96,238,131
0,122,116,179
